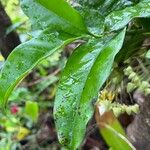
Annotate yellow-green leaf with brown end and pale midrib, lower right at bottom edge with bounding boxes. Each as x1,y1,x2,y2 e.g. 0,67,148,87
95,110,135,150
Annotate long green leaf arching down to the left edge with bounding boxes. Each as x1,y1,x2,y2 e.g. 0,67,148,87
0,30,81,108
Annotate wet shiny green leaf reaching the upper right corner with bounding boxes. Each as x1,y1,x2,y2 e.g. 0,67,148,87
105,0,150,31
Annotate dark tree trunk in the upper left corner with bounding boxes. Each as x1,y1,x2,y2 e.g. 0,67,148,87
0,2,20,59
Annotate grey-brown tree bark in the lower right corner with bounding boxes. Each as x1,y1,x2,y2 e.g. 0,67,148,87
127,91,150,150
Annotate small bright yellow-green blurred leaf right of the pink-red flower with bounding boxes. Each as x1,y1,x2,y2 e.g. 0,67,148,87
25,101,39,121
